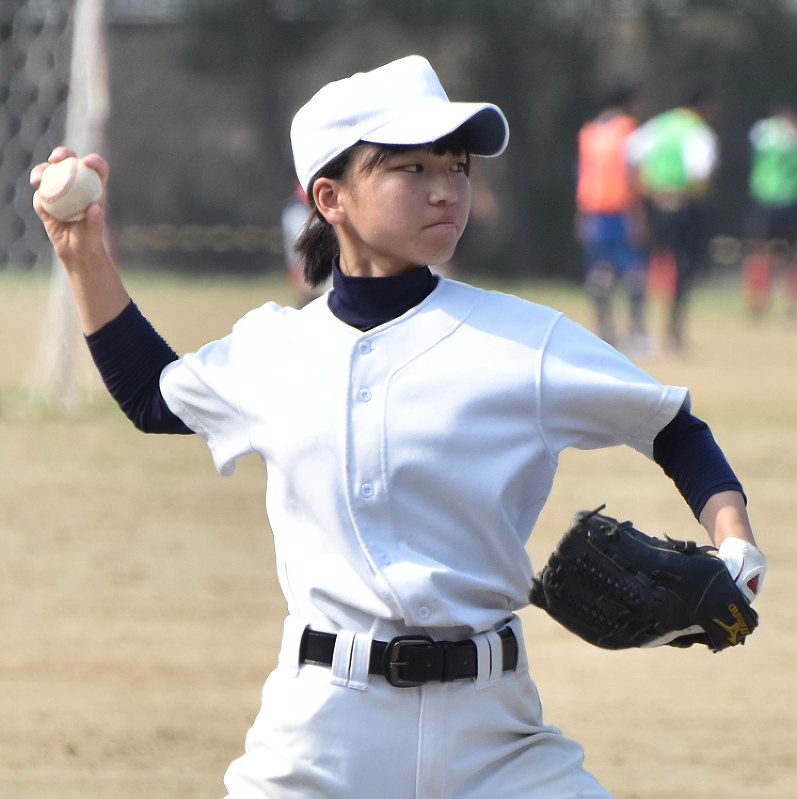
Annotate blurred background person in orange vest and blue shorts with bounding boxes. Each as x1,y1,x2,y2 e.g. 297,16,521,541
576,88,649,353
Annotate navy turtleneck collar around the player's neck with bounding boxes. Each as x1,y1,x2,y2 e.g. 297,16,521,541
328,266,438,330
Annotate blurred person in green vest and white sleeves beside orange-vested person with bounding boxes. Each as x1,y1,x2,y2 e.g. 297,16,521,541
628,89,719,351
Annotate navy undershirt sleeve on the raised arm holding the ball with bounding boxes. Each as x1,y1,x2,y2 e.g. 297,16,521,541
86,302,194,435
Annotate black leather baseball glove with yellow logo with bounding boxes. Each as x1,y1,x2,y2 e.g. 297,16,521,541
529,506,758,652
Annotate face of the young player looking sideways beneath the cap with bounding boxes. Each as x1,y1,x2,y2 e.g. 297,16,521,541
336,147,470,277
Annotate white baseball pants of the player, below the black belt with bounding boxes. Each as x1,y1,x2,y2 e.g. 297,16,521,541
225,619,610,799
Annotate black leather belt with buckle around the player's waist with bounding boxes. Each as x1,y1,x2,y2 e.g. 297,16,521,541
299,627,518,688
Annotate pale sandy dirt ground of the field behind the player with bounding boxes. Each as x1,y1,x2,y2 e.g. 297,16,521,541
0,276,797,799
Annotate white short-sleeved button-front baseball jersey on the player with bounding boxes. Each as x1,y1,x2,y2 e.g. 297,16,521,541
161,278,687,634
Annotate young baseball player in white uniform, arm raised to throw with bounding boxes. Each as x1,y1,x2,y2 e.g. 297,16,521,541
32,56,764,799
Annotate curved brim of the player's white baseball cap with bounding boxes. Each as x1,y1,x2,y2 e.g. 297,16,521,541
361,98,509,156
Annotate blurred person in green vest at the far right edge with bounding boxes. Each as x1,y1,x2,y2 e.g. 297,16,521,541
742,99,797,320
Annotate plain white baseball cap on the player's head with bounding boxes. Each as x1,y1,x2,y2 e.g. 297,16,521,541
291,55,509,188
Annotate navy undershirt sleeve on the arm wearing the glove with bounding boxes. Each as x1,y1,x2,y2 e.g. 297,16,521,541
653,408,744,518
